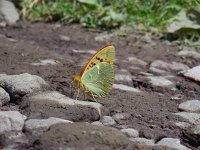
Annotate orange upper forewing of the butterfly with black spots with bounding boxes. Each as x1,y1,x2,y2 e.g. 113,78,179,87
80,45,115,76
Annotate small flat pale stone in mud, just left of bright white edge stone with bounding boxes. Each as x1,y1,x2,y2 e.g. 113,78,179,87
146,76,174,87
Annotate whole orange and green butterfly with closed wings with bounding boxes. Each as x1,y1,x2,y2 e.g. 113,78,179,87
73,45,115,101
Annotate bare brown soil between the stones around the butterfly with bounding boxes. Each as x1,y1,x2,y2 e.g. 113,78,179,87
0,23,200,149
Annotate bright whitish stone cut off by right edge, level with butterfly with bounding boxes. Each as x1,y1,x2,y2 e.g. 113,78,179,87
183,66,200,82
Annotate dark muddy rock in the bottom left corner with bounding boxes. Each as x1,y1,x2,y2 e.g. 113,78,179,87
0,131,28,149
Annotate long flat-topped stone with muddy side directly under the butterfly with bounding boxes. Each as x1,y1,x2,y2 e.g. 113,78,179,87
21,91,102,121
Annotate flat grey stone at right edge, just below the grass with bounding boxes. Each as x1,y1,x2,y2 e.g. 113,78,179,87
177,48,200,59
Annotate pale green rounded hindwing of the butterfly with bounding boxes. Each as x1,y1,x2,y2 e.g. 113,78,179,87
81,62,114,97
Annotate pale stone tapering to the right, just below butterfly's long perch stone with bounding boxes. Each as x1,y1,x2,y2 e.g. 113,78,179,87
25,117,73,135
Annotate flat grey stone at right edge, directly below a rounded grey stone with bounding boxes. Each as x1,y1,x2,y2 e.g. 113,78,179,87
174,112,200,124
